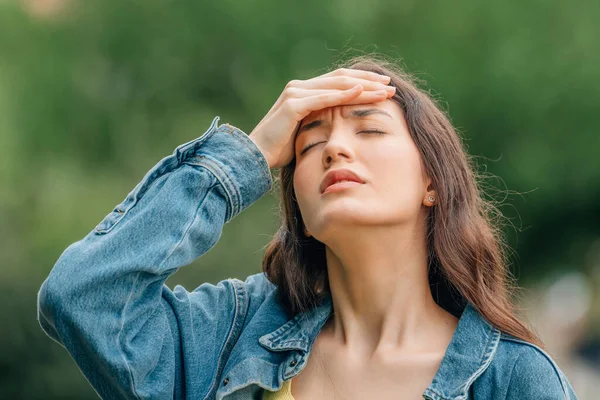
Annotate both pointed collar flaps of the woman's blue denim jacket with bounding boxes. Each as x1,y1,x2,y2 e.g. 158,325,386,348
258,294,500,400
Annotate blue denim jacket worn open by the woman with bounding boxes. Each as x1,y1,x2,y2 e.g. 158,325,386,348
37,117,576,400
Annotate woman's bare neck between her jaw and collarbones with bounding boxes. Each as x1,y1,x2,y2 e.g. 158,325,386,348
325,217,456,359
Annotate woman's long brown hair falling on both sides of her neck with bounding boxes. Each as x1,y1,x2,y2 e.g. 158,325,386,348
263,55,544,348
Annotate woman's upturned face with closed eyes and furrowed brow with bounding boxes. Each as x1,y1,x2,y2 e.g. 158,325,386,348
294,100,430,243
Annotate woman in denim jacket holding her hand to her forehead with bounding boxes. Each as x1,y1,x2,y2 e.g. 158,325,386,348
38,58,576,400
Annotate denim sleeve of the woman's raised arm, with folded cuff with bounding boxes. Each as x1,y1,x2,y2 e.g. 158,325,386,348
37,117,272,399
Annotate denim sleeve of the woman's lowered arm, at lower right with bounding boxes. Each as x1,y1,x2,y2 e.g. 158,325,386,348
506,346,577,400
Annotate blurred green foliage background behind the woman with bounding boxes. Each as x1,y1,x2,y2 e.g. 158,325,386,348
0,0,600,399
